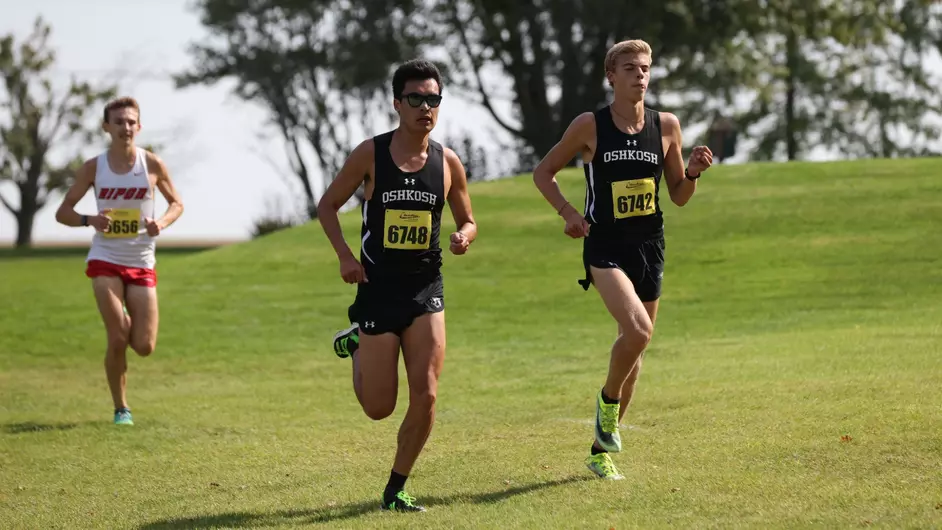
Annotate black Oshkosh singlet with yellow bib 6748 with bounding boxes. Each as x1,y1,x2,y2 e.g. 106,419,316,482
360,131,445,280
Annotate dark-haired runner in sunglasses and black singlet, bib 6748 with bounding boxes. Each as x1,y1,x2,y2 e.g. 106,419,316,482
318,60,477,512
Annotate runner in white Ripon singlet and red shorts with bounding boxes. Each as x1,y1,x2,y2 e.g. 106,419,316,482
56,98,183,425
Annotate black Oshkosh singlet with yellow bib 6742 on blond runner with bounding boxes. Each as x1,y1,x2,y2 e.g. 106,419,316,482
584,106,664,241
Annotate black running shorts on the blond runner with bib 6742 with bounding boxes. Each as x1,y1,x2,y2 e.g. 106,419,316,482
579,237,665,302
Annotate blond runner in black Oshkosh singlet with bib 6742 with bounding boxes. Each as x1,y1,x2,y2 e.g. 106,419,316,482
533,40,713,480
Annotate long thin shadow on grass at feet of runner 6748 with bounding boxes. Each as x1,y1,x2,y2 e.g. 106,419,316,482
140,475,594,530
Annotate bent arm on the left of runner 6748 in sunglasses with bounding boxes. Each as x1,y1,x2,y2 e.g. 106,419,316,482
317,140,374,261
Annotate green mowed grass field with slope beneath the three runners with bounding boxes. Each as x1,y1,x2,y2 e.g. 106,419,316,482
0,160,942,529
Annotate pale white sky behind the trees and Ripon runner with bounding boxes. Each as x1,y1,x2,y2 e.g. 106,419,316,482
0,0,516,246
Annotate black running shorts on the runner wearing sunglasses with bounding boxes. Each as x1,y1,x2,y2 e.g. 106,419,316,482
347,274,445,336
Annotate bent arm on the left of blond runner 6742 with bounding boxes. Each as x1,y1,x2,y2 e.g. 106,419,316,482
533,112,595,216
